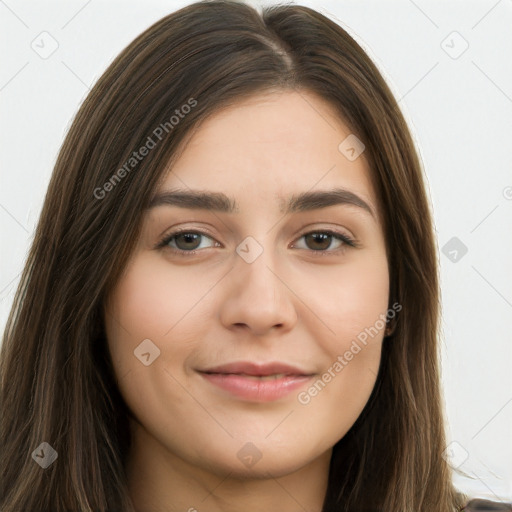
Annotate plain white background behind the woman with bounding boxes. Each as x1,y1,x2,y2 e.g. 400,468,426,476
0,0,512,501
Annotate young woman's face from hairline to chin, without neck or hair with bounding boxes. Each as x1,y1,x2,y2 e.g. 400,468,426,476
105,92,389,477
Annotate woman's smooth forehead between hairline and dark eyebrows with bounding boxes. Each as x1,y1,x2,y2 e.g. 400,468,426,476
157,91,376,218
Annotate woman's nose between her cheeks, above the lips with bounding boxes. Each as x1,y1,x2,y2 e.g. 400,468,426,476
220,243,298,336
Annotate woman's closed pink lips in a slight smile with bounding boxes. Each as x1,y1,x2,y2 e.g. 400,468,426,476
198,362,315,402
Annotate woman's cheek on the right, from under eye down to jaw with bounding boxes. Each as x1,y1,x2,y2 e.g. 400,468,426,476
290,252,389,414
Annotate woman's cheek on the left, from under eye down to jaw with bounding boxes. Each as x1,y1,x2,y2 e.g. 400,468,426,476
105,255,212,437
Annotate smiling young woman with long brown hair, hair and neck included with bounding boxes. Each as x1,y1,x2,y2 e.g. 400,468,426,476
0,1,508,512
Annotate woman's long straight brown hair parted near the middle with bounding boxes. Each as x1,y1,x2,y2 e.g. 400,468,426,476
0,0,466,512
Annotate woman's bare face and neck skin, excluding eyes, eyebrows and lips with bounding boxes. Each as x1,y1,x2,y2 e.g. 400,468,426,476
105,91,389,512
